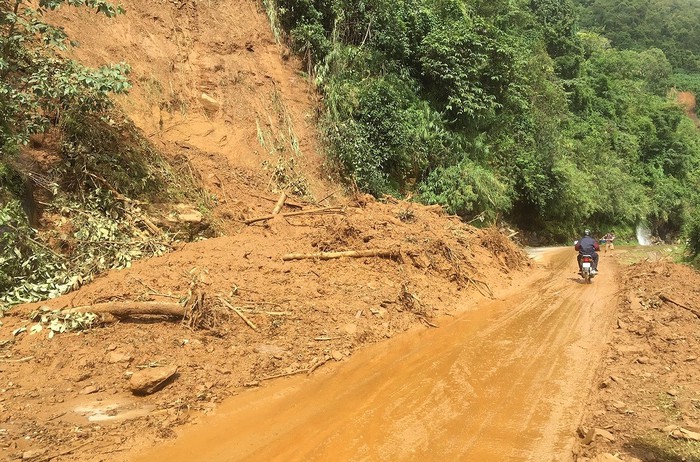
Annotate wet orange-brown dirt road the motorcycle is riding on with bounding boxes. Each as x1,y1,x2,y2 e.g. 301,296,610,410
135,248,618,462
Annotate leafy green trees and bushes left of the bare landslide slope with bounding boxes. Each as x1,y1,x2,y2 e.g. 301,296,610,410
0,0,202,310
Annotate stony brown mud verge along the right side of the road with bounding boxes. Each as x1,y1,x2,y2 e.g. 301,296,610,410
577,250,700,462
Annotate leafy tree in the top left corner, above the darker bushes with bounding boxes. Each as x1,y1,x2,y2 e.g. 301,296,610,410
0,0,130,157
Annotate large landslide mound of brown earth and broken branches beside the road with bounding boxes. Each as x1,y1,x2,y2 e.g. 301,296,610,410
0,196,529,460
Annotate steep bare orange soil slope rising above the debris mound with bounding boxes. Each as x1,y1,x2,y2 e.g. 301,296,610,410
49,0,337,233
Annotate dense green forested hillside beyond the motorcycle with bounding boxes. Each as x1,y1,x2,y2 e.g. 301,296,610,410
266,0,700,245
